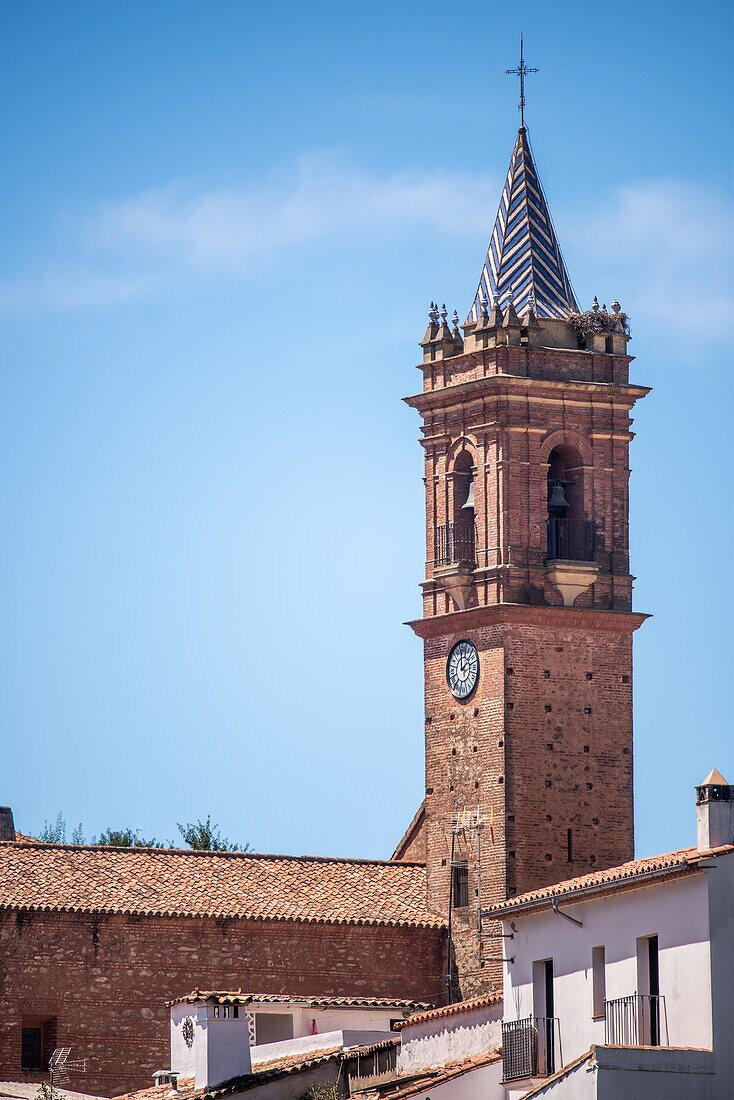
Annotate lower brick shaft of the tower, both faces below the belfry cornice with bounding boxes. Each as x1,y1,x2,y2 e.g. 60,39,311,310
425,612,634,997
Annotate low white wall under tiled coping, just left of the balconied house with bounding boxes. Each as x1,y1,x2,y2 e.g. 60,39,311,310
397,1002,502,1074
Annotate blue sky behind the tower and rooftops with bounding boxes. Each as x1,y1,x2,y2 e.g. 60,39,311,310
0,0,734,856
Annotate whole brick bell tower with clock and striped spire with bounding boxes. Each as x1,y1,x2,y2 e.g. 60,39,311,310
406,127,648,999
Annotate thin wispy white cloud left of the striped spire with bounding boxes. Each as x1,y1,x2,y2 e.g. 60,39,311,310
90,155,496,270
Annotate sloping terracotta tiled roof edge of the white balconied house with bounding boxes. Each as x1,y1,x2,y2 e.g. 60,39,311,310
487,844,734,917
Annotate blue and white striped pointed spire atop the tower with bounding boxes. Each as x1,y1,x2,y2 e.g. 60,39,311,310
467,127,579,322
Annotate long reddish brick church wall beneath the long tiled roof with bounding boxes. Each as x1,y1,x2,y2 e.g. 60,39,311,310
0,911,446,1096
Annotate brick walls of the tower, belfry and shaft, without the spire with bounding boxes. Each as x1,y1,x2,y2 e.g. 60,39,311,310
408,334,645,997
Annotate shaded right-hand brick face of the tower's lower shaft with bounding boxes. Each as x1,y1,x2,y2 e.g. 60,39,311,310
505,626,634,894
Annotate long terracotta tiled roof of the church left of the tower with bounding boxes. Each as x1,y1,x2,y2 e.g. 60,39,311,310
0,840,443,927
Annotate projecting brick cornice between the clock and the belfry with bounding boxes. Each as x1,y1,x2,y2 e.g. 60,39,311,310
405,604,650,638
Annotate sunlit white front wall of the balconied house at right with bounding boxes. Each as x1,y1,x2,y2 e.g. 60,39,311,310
504,857,713,1067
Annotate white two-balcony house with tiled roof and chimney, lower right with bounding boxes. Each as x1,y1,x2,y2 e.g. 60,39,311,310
490,771,734,1100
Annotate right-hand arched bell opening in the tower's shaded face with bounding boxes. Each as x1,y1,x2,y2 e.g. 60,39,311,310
547,443,594,561
